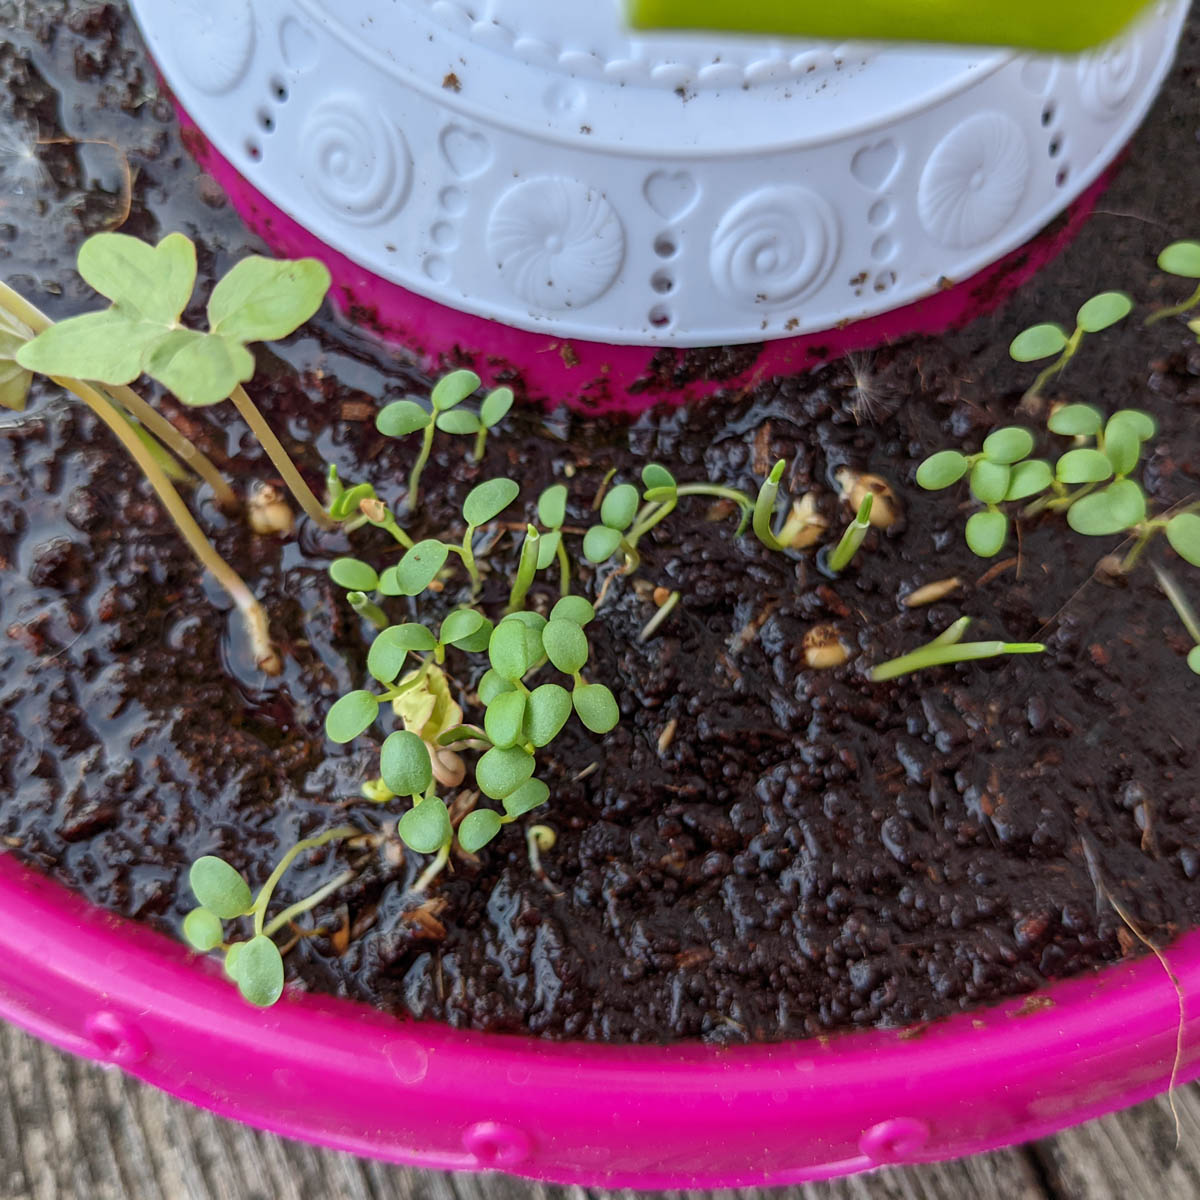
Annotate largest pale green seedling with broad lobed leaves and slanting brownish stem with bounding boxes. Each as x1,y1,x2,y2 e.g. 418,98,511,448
17,233,332,528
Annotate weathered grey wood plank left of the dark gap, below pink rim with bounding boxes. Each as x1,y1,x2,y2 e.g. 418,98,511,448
0,1026,1051,1200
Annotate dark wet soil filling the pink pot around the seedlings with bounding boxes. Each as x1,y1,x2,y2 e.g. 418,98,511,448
0,0,1200,1042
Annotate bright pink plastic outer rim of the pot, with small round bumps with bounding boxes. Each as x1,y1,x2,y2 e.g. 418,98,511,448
0,854,1200,1188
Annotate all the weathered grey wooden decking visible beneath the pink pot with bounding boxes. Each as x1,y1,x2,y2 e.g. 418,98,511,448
9,1026,1171,1200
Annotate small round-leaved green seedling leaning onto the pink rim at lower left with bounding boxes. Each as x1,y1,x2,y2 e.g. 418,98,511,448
184,826,359,1008
